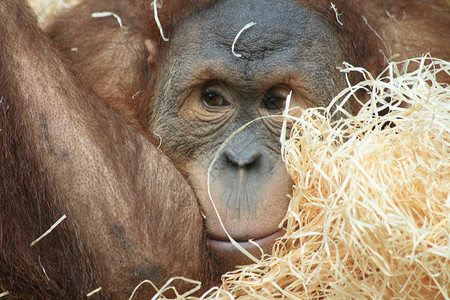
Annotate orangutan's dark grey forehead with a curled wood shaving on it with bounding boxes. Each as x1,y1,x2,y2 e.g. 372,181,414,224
172,0,334,55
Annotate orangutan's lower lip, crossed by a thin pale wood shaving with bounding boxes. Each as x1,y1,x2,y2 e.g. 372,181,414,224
208,230,284,255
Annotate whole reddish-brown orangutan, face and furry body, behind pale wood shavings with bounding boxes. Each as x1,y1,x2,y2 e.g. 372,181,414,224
0,0,445,299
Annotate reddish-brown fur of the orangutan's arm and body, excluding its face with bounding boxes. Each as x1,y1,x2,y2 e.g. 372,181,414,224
0,0,449,299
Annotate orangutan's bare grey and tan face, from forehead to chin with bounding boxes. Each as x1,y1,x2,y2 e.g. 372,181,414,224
149,0,345,269
